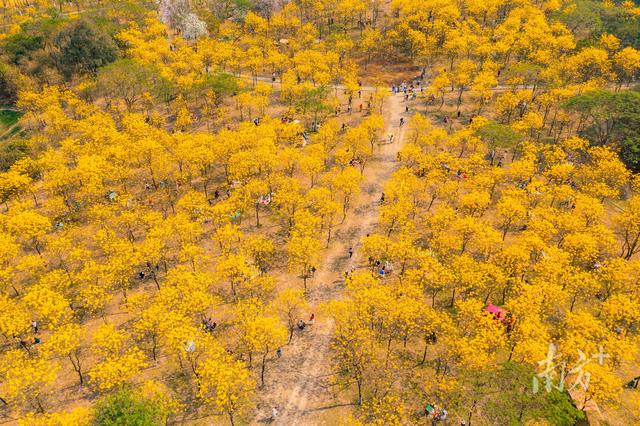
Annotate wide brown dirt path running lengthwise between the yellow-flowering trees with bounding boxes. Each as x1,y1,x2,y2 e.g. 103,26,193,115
254,89,408,426
